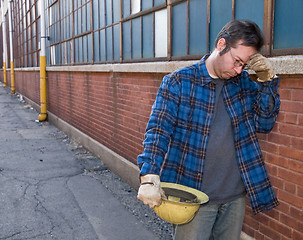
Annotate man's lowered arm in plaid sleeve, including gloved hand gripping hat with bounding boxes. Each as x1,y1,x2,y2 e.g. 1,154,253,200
137,76,180,208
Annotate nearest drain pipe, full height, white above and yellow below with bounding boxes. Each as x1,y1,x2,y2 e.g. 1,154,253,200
39,1,48,122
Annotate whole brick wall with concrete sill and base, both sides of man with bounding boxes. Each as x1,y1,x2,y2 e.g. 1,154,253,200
1,56,303,240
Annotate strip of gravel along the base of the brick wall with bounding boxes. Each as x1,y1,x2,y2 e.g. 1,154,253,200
54,130,172,240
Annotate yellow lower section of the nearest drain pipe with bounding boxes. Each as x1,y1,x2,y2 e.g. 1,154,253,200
39,56,47,121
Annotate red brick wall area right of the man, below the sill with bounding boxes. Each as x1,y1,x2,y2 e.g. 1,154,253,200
243,76,303,240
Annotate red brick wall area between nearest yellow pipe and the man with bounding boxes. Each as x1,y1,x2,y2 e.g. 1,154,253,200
48,72,163,163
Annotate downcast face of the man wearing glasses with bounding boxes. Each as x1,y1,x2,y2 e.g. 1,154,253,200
214,39,257,79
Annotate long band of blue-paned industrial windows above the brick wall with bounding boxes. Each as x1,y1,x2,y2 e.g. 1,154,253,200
6,0,303,67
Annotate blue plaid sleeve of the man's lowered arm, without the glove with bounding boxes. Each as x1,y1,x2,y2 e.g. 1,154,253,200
137,75,180,175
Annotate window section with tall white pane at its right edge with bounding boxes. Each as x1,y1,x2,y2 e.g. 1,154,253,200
121,0,168,62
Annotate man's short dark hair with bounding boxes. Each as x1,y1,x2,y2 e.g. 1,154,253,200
215,20,264,55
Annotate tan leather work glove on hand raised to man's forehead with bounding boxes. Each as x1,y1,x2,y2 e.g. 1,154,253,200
248,53,274,82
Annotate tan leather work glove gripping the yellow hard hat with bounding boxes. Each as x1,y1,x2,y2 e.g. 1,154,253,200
137,174,166,208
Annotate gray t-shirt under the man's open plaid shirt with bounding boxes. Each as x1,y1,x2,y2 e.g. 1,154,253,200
202,79,246,204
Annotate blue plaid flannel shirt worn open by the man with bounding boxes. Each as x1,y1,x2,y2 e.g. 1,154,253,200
137,56,280,214
